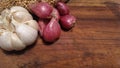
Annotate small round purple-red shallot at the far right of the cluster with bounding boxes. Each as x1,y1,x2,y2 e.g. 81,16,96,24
60,15,76,30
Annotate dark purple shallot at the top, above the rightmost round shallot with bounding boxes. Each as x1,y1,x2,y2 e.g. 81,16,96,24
56,2,70,16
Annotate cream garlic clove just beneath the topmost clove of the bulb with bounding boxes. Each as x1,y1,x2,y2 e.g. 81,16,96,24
13,12,33,23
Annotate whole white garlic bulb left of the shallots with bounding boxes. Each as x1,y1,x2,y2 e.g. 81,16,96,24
0,6,38,51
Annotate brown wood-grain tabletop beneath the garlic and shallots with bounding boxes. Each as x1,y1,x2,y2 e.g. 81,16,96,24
0,0,120,68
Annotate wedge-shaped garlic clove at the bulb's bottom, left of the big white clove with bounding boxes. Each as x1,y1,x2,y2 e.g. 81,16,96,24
11,33,26,50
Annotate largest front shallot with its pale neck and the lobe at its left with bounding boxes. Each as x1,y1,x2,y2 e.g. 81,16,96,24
38,8,61,42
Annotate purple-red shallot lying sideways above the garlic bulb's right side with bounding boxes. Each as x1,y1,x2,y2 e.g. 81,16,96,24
29,2,53,18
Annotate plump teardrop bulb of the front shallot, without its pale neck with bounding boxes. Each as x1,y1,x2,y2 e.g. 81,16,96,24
43,18,61,43
